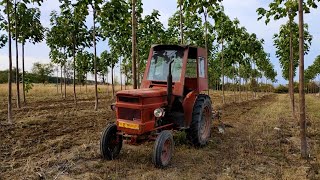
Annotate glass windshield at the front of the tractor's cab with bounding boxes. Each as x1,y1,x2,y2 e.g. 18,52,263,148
148,50,183,82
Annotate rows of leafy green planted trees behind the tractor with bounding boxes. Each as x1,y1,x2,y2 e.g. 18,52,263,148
0,0,319,158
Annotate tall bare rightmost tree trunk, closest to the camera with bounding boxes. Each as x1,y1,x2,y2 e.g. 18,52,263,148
299,0,308,159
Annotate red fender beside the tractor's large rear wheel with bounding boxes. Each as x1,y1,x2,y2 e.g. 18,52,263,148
182,90,198,128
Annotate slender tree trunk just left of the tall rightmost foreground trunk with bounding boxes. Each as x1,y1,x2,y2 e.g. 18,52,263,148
289,18,296,118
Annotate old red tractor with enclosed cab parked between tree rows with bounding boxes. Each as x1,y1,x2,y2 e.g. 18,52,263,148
100,45,212,167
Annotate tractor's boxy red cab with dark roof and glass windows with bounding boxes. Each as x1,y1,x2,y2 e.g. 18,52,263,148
141,45,208,97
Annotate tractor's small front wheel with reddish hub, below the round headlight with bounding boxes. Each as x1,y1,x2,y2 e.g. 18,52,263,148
152,130,174,168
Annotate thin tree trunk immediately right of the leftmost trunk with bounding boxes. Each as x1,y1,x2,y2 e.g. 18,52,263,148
14,0,21,108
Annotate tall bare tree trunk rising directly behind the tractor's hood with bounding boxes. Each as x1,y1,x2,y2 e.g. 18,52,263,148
131,0,137,89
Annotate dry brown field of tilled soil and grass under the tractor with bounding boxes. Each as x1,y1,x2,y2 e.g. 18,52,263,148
0,85,320,180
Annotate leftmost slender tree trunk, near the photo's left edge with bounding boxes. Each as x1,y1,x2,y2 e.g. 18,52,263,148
6,0,12,124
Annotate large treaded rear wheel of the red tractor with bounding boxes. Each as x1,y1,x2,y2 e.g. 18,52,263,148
187,94,212,147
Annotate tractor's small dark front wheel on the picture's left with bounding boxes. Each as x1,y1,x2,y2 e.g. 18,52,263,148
100,124,122,160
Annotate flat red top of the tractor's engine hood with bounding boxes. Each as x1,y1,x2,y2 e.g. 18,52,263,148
117,88,167,98
